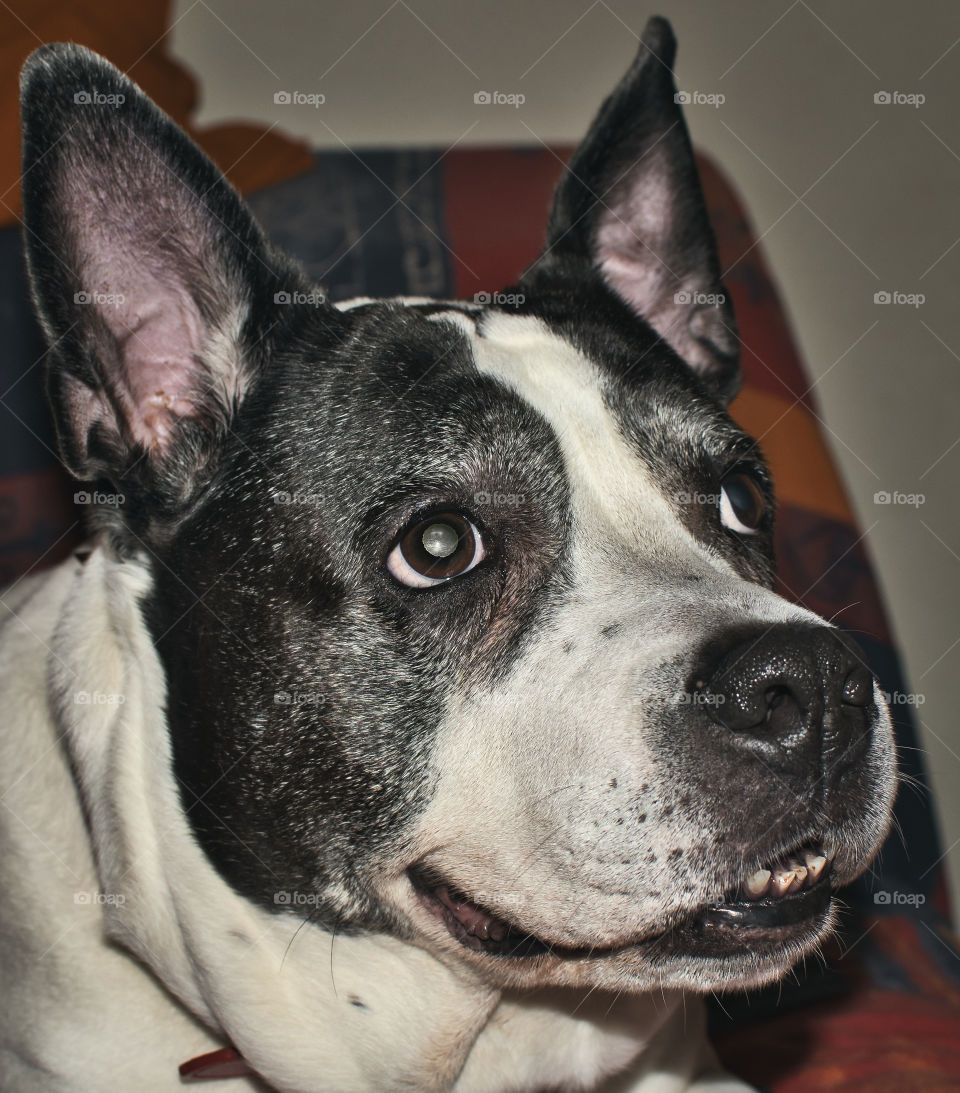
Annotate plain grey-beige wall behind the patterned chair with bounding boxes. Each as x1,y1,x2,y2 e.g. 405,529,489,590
173,0,960,907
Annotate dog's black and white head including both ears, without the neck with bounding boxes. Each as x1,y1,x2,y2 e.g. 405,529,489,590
24,21,894,990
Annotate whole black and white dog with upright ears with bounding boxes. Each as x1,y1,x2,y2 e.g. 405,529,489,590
0,20,895,1093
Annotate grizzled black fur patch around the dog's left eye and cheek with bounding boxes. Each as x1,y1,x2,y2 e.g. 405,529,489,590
148,305,567,929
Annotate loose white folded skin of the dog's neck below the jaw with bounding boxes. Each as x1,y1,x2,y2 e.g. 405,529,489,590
50,544,695,1093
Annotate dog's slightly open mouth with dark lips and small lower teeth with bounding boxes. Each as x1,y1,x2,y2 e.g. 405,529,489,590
409,845,831,960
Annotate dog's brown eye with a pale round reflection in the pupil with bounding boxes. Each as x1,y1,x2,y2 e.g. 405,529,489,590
387,513,487,588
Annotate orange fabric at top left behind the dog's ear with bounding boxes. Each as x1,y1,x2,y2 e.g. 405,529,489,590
0,0,313,227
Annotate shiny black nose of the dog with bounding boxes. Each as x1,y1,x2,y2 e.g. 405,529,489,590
698,624,876,774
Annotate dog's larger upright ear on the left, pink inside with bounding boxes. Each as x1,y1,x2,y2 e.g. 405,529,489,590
21,45,302,507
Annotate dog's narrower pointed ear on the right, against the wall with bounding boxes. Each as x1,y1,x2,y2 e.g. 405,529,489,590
535,17,739,401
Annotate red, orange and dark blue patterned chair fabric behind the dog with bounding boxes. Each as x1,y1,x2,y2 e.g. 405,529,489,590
0,149,960,1093
